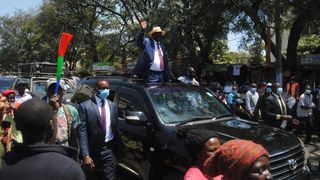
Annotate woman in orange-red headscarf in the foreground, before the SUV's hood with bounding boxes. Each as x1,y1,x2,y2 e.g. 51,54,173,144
204,139,272,180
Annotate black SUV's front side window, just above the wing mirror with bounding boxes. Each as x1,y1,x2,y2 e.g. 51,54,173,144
117,87,147,118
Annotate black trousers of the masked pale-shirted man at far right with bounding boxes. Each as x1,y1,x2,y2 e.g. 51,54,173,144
294,116,313,143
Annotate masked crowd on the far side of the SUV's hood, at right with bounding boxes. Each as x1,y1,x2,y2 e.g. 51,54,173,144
206,77,320,144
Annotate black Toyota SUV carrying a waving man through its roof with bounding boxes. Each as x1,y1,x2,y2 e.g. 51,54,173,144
73,77,310,180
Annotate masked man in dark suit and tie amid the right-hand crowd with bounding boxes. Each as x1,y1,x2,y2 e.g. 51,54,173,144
262,83,292,129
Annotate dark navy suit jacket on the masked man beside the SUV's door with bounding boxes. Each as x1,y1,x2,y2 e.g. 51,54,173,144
78,96,120,160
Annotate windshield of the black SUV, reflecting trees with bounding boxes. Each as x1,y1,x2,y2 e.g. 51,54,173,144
148,87,232,124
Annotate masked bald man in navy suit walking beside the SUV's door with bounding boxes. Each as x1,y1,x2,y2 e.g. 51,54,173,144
78,80,119,179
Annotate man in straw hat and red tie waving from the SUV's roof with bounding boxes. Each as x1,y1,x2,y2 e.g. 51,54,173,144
133,20,172,83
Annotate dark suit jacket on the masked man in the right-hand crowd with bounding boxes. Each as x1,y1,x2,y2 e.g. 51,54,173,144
261,94,288,128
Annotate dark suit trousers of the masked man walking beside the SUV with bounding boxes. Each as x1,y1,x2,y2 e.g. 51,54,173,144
85,141,118,180
